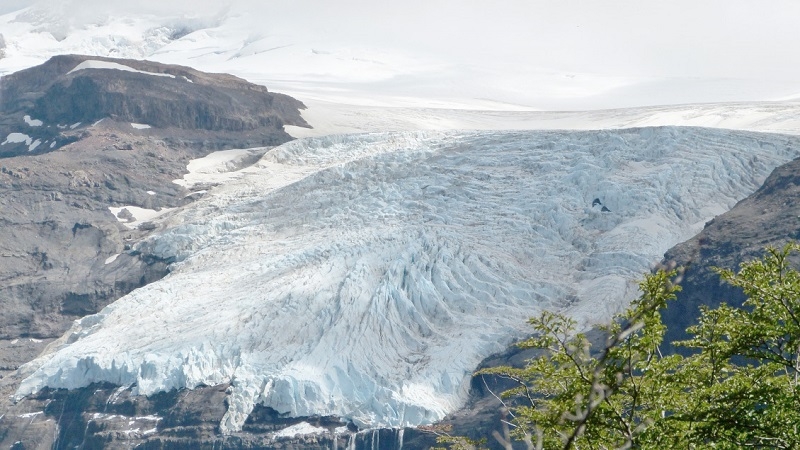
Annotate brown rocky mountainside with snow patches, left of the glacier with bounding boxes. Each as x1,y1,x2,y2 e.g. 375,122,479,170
0,56,306,448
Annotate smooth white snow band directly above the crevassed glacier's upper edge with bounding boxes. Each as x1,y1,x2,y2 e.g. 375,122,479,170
286,99,800,138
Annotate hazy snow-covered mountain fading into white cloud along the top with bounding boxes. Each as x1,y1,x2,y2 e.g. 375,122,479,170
0,0,800,110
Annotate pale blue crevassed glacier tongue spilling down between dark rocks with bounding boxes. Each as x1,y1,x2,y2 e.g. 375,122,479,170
17,127,800,432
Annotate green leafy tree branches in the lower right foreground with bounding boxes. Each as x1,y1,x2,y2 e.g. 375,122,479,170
443,243,800,449
